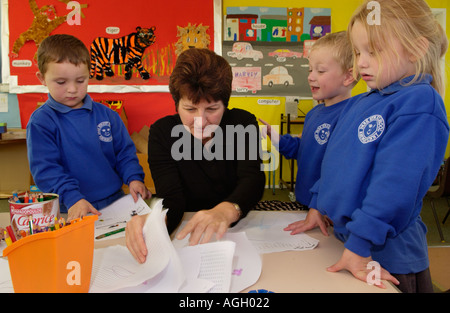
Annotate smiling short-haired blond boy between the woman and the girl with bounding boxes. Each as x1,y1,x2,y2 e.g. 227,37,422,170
260,31,357,235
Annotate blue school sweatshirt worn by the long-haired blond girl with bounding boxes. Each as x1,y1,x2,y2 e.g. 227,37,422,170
311,75,449,274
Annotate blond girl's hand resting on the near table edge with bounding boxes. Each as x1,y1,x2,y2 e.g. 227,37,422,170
327,249,400,289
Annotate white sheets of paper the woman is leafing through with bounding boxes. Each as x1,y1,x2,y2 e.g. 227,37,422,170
90,200,261,293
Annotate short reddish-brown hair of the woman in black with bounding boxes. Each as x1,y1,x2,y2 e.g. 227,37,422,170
169,48,233,109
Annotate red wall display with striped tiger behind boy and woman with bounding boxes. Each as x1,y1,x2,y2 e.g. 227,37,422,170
2,0,214,132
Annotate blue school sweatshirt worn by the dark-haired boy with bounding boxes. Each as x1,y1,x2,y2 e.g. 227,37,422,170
27,95,144,208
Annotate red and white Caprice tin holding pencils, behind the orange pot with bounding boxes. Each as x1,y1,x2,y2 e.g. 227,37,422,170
8,193,59,233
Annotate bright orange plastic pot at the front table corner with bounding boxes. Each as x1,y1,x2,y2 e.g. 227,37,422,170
3,215,98,293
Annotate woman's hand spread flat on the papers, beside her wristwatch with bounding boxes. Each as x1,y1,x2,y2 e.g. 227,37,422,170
176,202,240,246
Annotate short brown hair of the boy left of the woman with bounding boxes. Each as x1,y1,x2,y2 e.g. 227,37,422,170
37,34,91,75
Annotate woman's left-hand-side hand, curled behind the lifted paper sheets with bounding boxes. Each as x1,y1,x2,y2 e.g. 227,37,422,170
125,214,148,263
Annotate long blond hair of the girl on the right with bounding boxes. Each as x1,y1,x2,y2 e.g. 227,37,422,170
348,0,448,96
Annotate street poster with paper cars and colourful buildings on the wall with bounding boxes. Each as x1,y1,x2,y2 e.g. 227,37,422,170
222,7,331,97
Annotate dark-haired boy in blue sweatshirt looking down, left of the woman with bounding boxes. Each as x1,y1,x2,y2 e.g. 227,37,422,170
27,35,150,220
